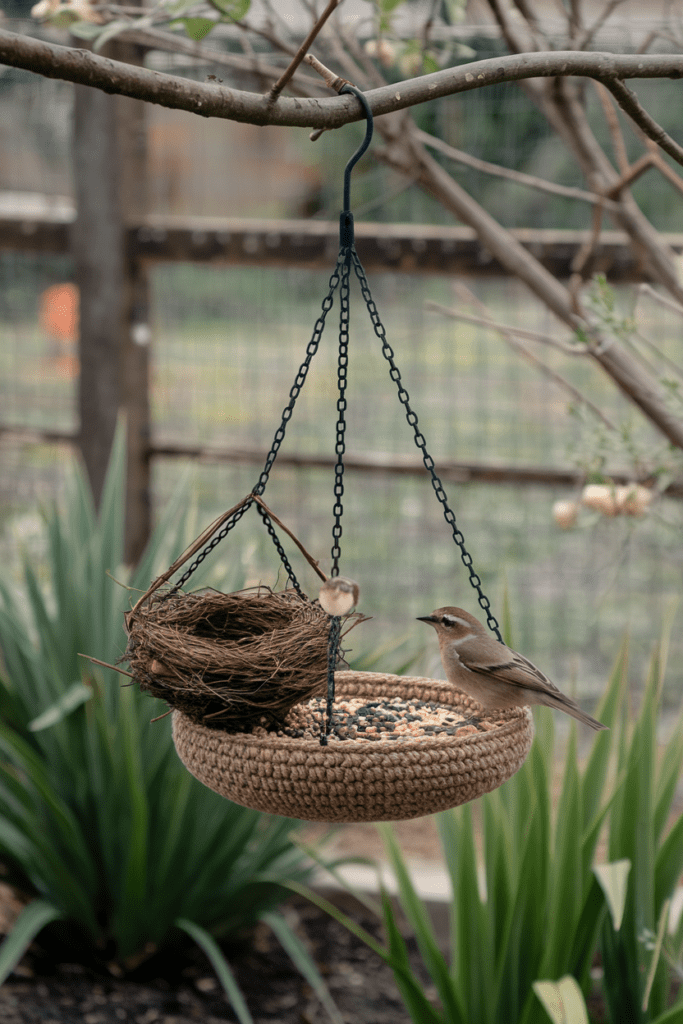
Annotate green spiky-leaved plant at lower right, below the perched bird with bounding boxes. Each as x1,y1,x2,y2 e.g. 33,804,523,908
290,602,683,1024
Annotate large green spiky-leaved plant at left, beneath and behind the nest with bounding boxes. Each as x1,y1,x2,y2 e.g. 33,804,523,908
0,430,340,1024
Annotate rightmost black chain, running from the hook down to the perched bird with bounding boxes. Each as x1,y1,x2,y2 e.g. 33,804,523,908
351,247,503,643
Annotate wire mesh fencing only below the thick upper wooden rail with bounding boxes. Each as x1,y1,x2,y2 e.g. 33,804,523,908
0,253,683,712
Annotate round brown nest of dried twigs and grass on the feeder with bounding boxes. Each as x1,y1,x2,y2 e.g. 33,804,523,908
124,587,348,732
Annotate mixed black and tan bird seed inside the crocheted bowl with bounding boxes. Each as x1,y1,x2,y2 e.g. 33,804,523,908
253,697,505,741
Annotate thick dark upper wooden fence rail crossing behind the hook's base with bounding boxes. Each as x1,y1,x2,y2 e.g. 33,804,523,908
0,202,683,282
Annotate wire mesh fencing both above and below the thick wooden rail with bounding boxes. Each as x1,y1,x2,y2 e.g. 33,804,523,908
0,52,683,720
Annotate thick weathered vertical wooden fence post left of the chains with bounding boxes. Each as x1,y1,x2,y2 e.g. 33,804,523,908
72,43,151,563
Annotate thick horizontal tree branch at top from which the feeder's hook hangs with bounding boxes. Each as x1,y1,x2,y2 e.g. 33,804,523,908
0,30,683,136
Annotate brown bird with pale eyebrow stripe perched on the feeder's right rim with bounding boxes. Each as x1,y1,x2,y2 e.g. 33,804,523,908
419,608,607,729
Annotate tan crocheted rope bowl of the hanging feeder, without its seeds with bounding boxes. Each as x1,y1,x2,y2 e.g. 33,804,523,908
173,672,533,822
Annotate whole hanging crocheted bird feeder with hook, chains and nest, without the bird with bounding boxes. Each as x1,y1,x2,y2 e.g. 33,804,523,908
117,83,533,822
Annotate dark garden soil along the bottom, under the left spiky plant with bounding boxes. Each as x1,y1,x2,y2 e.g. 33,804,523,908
0,896,436,1024
